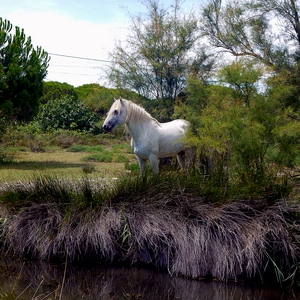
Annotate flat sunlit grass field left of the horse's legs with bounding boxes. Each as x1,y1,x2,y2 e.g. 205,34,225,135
0,147,135,184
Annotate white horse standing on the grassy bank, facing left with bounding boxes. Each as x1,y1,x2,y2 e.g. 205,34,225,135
103,97,189,174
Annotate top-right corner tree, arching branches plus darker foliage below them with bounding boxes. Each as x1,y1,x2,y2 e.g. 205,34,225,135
201,0,300,114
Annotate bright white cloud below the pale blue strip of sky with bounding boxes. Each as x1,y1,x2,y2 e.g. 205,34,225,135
3,10,126,86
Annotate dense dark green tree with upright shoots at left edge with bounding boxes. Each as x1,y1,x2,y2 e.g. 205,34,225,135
0,18,49,120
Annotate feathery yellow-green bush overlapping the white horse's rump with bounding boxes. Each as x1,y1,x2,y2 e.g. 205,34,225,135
175,62,300,187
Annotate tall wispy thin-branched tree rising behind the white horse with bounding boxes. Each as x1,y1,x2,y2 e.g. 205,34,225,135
108,0,212,117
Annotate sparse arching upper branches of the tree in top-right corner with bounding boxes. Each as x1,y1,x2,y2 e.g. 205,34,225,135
201,0,300,69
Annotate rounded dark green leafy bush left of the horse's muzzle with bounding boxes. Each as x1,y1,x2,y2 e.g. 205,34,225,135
36,96,99,132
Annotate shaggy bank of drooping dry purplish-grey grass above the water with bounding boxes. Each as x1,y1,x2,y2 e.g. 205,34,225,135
0,176,300,283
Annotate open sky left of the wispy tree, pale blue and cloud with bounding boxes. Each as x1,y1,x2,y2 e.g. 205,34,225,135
0,0,204,86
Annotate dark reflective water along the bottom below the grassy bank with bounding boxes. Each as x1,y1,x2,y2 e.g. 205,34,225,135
0,261,300,300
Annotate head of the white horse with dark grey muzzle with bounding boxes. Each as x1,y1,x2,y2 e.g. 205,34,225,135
102,97,126,131
